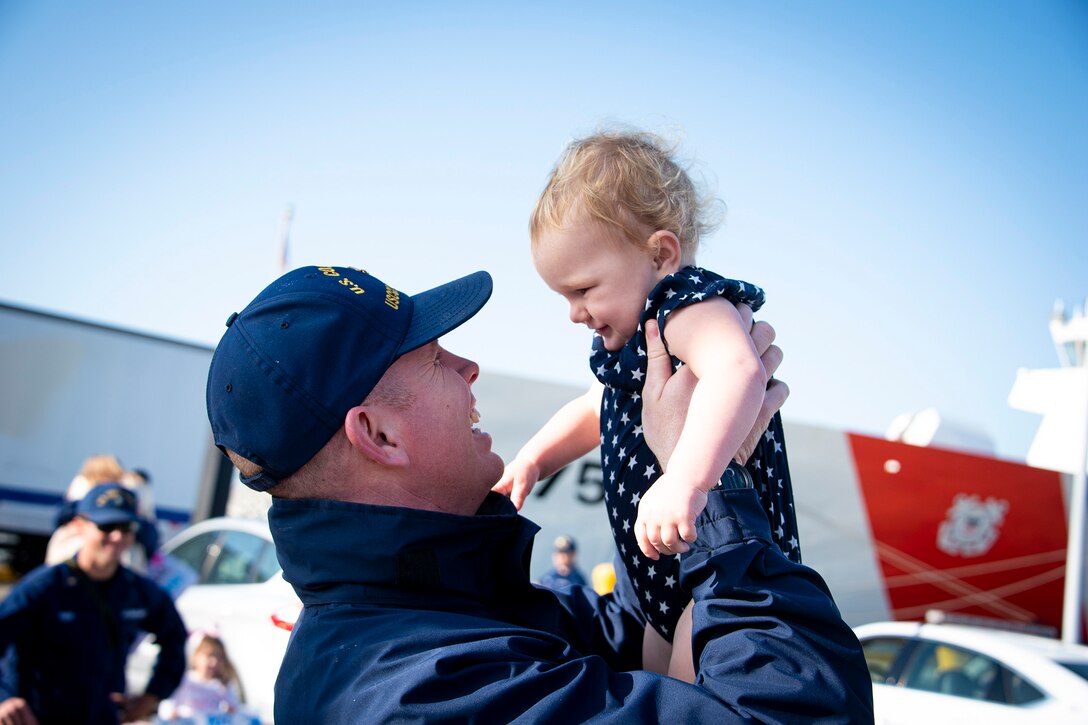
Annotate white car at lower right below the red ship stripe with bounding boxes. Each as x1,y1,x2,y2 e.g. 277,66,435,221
854,622,1088,725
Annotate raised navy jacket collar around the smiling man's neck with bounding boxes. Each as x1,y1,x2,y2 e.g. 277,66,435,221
269,493,540,611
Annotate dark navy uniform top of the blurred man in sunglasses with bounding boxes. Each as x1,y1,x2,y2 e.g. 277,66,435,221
0,555,186,725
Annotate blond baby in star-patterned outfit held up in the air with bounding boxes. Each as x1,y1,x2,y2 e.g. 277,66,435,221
495,132,800,681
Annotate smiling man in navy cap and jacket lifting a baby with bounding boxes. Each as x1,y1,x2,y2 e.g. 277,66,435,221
207,267,873,723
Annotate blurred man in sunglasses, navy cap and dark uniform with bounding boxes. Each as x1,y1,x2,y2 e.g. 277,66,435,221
0,483,185,725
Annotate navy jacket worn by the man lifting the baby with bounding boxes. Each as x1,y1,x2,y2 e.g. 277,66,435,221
269,490,873,724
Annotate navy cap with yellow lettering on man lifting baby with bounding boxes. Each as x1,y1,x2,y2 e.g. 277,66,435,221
208,267,492,491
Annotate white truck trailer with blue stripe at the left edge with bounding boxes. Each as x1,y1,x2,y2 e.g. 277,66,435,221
0,303,232,579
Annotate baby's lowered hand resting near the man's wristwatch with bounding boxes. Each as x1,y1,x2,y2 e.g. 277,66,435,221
634,474,706,560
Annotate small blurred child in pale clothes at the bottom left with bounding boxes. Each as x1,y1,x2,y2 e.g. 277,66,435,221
159,631,244,723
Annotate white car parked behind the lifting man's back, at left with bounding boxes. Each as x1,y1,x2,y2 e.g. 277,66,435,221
128,517,301,723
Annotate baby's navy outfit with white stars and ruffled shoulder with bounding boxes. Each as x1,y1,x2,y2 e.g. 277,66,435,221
590,267,801,641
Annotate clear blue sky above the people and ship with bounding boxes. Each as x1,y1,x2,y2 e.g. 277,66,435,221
0,0,1088,457
